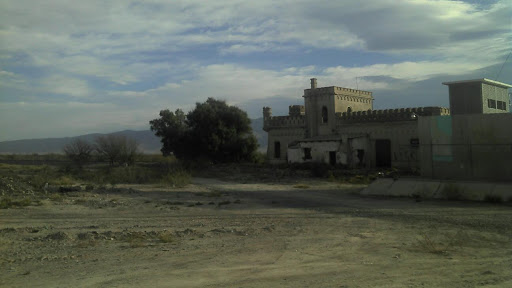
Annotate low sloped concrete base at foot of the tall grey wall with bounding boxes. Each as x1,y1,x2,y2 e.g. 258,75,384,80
361,178,512,202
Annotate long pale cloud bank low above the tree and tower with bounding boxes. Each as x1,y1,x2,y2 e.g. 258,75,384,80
104,61,481,110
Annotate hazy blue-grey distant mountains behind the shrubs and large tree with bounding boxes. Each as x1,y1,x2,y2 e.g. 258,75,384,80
0,118,267,154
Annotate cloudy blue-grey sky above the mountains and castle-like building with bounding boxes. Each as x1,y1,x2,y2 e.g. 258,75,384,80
0,0,512,141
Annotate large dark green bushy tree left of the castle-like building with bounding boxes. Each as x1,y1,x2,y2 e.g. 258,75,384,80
149,98,258,162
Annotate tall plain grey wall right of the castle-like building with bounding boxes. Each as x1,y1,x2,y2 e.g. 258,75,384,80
418,113,512,181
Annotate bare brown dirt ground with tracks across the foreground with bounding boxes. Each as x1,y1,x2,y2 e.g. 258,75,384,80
0,178,512,287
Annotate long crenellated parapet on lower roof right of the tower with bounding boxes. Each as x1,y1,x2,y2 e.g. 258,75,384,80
336,107,450,124
